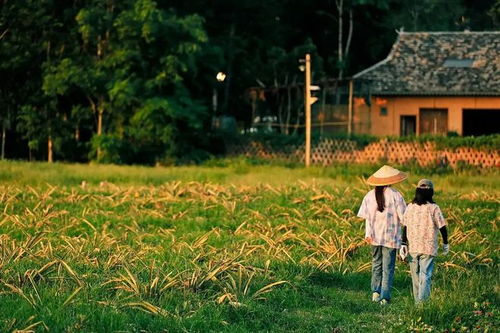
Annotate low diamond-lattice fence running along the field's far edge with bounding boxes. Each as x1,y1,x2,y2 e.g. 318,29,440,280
228,139,500,168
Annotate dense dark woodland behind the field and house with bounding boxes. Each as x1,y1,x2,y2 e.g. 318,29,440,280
0,0,499,164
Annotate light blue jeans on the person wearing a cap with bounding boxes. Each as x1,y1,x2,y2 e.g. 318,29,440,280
409,253,434,303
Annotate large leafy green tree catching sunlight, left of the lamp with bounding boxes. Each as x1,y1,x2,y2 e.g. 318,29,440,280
44,0,206,159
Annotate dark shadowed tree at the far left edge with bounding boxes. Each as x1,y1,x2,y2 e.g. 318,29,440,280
0,0,82,162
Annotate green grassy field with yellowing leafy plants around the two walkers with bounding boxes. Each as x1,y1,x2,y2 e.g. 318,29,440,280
0,160,500,332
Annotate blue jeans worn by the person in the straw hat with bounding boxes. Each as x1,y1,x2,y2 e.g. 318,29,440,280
372,246,396,301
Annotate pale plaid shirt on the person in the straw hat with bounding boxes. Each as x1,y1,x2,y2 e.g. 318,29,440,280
358,187,406,249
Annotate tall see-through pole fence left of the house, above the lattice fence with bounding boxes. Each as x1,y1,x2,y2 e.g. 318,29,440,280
246,79,370,135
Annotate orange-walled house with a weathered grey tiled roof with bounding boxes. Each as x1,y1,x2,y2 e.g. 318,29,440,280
353,31,500,135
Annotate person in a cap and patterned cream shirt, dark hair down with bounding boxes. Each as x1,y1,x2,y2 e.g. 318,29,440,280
400,179,450,303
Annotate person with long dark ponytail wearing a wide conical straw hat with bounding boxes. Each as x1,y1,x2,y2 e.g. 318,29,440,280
358,165,407,305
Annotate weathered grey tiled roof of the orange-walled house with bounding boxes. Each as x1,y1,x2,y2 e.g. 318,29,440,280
353,31,500,96
